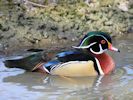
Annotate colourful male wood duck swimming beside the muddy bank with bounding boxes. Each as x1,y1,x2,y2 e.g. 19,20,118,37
4,31,120,77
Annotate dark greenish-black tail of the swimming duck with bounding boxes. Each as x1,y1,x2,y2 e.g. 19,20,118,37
4,53,44,71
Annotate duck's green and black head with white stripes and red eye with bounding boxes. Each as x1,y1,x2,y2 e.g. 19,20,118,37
73,31,120,55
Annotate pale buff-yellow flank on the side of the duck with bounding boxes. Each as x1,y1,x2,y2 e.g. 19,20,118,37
50,61,98,77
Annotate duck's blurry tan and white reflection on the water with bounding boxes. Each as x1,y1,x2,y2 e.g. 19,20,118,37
3,72,122,93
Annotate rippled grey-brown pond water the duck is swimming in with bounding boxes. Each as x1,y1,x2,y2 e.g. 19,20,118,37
0,39,133,100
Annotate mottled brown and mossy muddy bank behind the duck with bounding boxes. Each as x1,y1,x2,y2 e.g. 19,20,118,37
0,0,133,53
